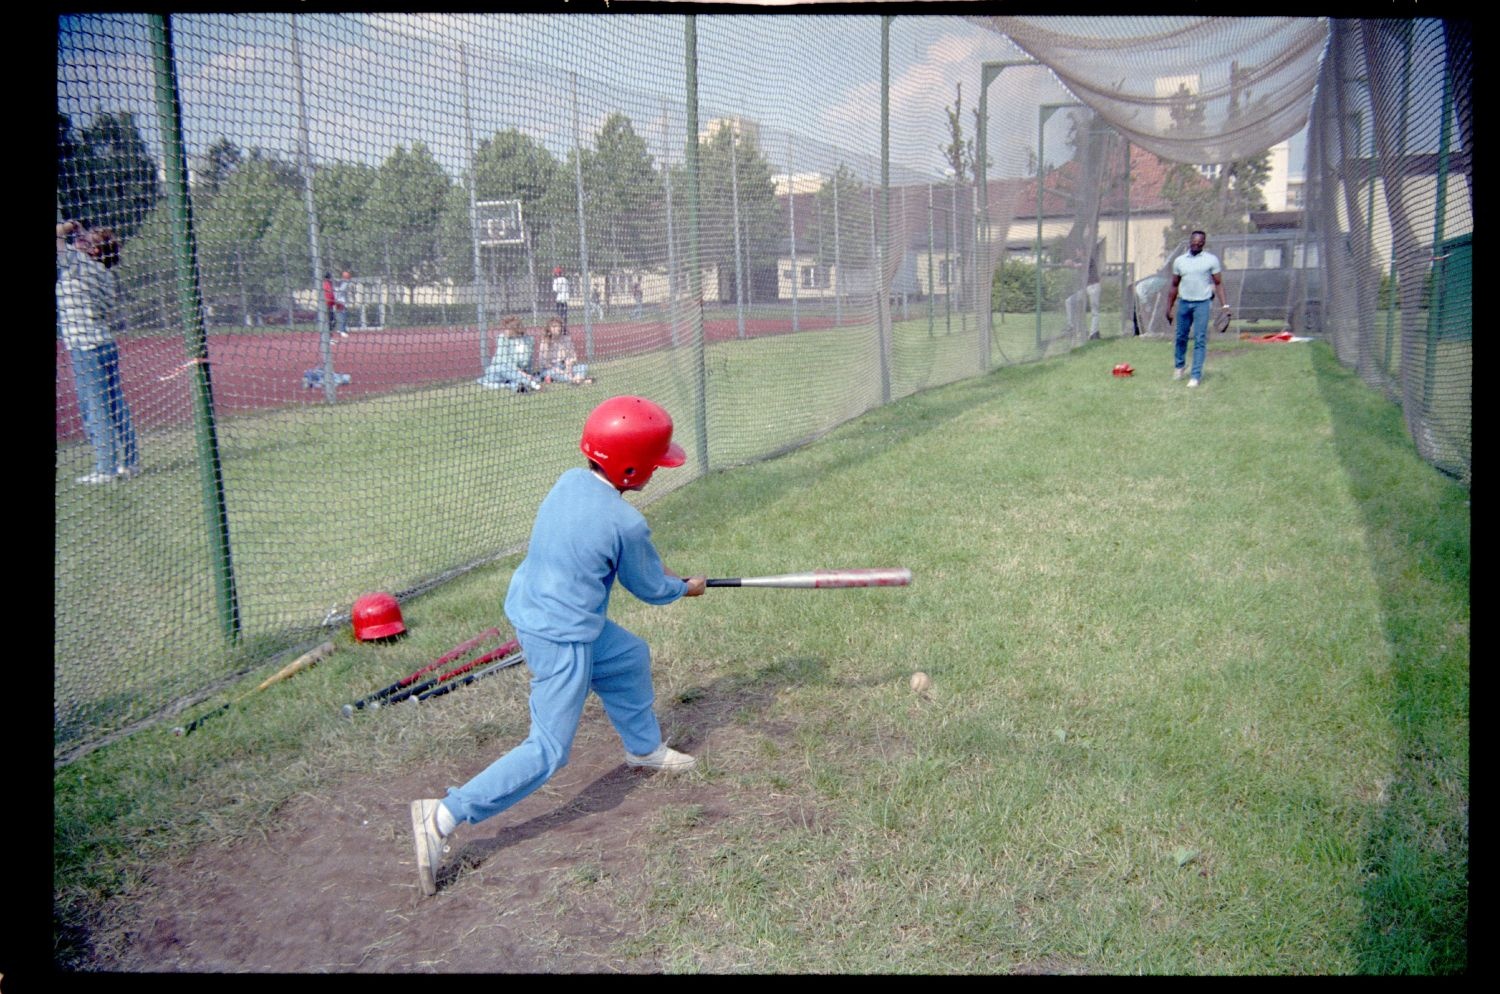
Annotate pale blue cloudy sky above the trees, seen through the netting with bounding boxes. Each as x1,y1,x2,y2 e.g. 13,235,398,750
59,13,1326,181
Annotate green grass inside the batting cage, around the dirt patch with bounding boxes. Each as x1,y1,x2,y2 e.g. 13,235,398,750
54,338,1470,975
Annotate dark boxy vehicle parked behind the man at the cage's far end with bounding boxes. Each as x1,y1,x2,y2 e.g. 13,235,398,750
1166,229,1323,334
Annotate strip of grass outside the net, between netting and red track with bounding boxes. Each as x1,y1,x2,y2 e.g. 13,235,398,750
53,313,1068,750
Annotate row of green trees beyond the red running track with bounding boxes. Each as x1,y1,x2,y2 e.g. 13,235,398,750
57,112,873,325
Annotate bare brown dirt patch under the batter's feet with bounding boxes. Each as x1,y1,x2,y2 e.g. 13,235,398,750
81,689,786,973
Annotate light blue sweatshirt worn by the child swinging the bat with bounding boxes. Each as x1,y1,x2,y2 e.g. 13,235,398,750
506,468,687,642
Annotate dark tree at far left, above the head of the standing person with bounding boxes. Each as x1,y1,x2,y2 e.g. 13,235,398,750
57,111,162,238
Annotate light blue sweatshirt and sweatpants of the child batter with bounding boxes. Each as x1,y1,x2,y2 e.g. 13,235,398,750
443,468,687,823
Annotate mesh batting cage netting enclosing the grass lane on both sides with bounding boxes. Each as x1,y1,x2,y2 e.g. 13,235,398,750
54,13,1473,763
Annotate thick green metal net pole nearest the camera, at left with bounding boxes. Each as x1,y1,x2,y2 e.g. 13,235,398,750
150,13,240,642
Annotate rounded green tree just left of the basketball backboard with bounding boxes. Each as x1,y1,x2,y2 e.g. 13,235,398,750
368,141,453,298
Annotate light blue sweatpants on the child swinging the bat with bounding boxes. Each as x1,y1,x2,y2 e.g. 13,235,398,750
443,621,662,825
